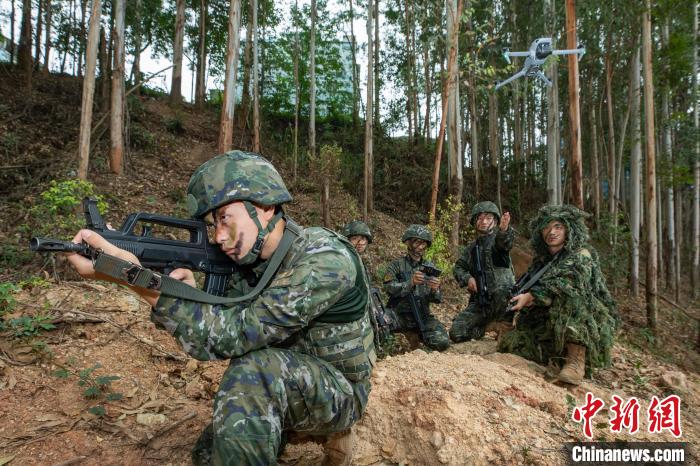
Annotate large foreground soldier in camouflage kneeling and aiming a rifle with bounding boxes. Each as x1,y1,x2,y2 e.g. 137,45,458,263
64,151,376,465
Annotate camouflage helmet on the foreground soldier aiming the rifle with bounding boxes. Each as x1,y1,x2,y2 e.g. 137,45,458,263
187,150,292,219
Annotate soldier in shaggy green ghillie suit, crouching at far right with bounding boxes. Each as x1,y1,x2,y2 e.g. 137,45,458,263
498,205,617,385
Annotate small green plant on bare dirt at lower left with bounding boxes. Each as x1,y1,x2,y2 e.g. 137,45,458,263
52,358,123,417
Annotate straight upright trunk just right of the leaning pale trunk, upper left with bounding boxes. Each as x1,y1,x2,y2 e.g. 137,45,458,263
109,0,126,175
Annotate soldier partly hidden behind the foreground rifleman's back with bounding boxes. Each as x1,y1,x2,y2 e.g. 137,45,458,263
342,220,398,358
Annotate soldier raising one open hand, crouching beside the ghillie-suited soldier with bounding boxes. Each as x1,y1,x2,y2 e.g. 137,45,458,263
450,201,515,343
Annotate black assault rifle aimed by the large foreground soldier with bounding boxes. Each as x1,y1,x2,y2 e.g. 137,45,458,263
29,198,236,296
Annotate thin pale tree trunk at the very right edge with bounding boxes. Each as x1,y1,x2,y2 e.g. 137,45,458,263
691,2,700,298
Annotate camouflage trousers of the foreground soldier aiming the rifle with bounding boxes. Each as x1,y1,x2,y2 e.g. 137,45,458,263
192,348,370,466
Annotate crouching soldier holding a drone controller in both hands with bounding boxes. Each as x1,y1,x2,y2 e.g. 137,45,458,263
384,225,450,351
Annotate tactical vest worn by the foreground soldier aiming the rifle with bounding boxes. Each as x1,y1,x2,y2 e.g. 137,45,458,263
290,230,377,382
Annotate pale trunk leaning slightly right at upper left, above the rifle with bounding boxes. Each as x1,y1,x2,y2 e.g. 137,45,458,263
78,0,102,180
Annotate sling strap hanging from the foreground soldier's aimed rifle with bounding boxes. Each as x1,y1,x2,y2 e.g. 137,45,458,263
94,219,302,304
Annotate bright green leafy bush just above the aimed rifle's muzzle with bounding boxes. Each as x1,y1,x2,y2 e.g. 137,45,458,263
21,179,107,239
